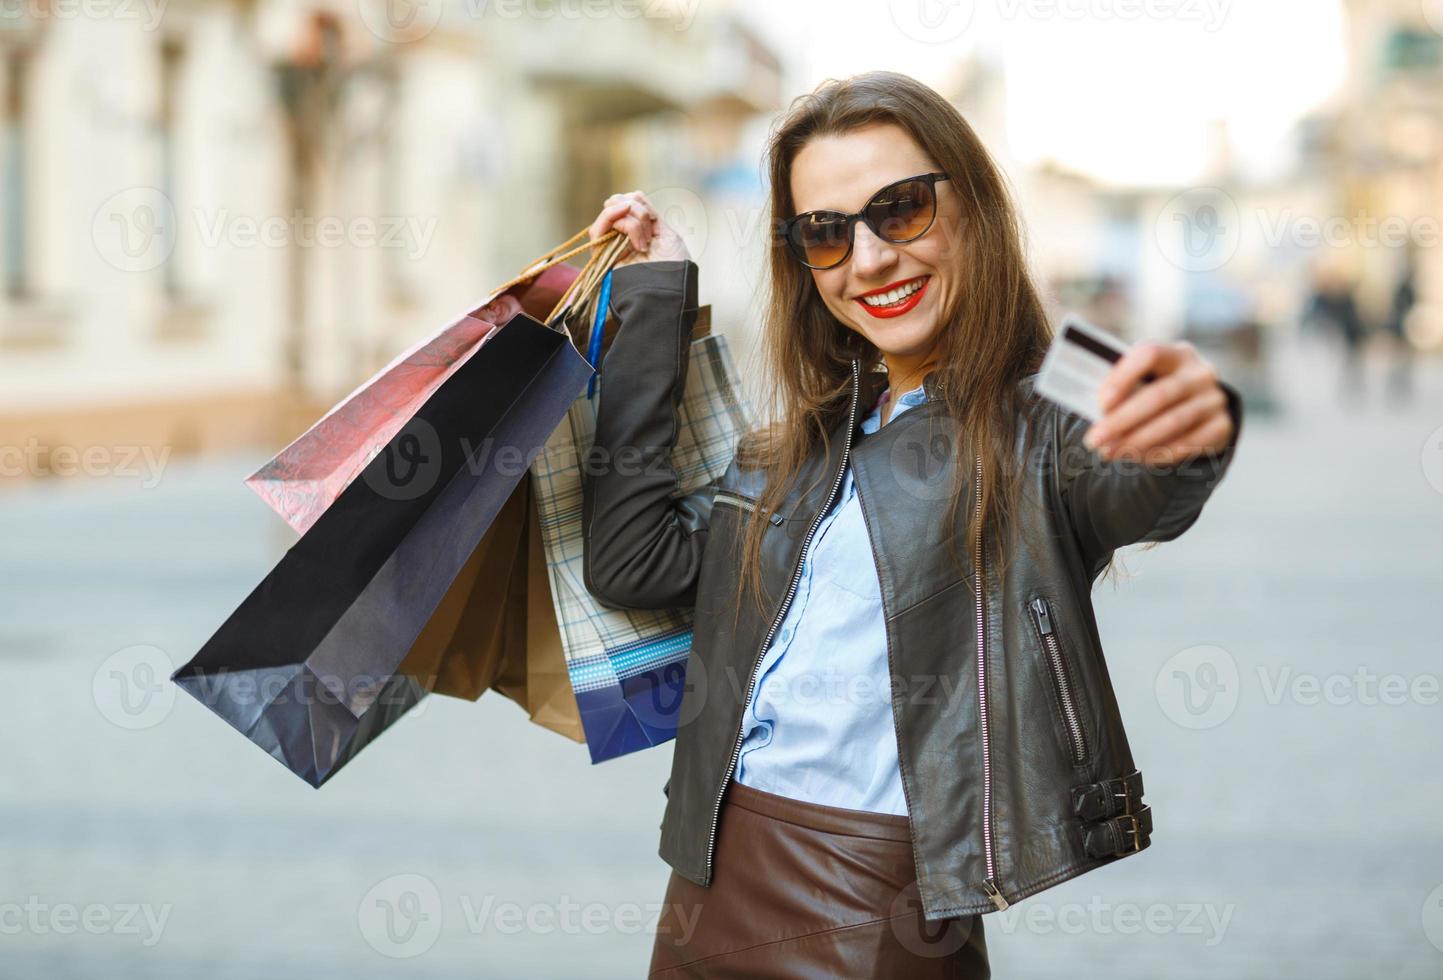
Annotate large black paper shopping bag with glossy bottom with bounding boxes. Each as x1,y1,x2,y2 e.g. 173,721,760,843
172,313,592,787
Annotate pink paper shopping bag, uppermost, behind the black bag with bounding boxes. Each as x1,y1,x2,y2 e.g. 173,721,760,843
245,234,593,534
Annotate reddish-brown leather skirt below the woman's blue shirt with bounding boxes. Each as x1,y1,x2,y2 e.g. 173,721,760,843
648,779,991,980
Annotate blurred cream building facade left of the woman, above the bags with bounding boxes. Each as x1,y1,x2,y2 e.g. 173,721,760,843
0,0,781,476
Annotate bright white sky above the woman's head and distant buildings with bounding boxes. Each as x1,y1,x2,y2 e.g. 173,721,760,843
737,0,1345,185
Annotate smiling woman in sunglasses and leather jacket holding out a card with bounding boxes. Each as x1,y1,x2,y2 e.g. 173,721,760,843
584,72,1241,977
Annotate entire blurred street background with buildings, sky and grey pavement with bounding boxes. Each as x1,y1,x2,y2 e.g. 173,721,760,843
0,0,1443,980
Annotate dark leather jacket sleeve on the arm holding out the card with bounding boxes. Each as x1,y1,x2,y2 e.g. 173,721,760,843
1053,381,1242,574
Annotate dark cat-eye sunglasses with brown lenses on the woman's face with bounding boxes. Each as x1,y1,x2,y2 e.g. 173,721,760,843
779,173,947,268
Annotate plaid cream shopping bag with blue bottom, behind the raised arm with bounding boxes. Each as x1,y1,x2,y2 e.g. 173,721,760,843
531,291,750,764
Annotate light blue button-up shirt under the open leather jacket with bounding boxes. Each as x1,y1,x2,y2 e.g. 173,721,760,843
736,385,926,815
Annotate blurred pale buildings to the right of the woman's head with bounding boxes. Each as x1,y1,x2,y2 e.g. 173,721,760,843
948,9,1443,410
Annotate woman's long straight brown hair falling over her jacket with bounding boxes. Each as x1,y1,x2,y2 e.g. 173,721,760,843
734,72,1052,616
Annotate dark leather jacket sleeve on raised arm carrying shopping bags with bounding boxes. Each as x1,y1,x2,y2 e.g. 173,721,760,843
582,260,719,609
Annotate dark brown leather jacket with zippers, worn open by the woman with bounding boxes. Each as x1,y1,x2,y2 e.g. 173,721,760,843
583,261,1242,919
